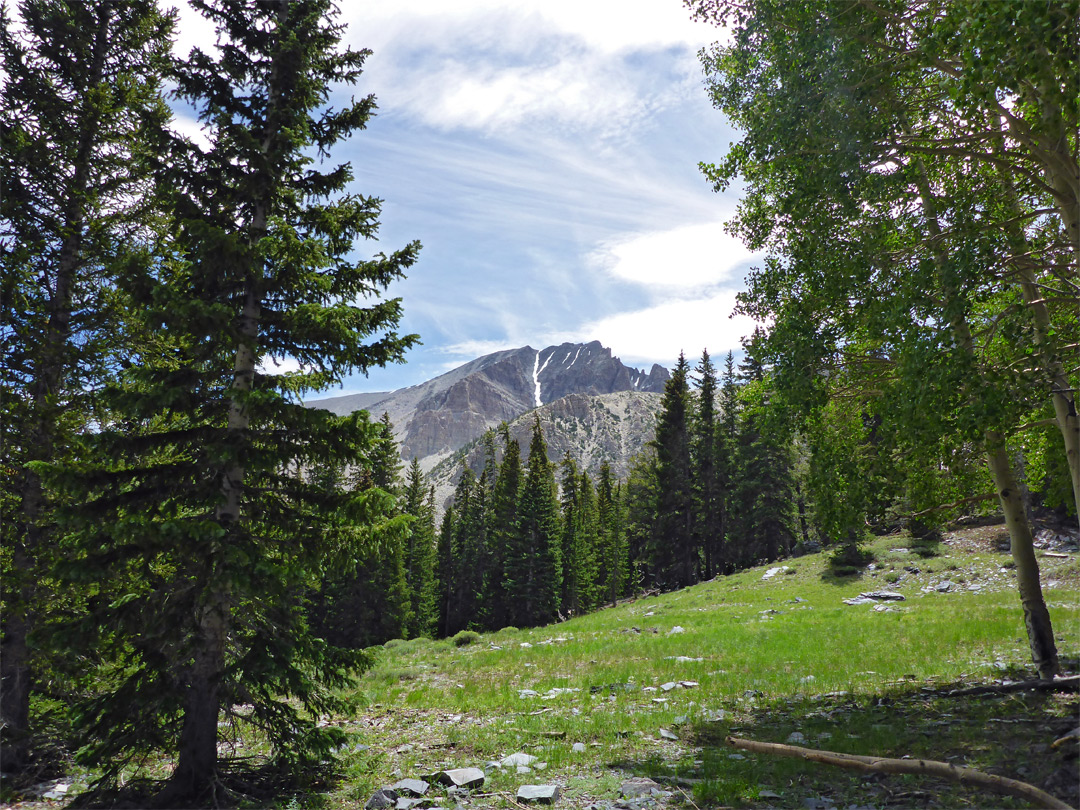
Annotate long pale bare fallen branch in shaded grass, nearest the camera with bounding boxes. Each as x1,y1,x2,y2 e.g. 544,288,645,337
726,737,1074,810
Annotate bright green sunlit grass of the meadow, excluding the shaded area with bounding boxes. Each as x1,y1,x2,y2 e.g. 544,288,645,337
330,538,1080,806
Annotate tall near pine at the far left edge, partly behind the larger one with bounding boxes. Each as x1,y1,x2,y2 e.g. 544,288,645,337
0,0,172,770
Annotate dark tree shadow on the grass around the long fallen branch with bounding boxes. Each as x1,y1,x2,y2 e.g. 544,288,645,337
618,674,1080,810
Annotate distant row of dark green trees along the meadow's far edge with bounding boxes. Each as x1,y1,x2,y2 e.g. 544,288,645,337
334,338,1067,646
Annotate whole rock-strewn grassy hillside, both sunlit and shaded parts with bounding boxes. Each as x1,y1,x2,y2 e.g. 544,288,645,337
329,527,1080,808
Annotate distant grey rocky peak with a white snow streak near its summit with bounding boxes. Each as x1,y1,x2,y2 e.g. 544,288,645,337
308,341,669,471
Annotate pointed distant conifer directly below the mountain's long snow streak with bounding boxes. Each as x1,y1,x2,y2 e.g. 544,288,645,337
507,417,563,626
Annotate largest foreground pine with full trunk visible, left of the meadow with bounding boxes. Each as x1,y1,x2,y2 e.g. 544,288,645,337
51,0,418,806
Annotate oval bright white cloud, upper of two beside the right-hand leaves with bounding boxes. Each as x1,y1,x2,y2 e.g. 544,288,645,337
590,222,758,288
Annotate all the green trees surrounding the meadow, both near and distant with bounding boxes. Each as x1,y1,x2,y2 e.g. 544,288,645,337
0,0,1080,808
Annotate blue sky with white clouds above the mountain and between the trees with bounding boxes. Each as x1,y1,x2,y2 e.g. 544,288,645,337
170,0,754,395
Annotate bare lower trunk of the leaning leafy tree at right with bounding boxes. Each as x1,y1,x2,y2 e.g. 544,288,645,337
986,432,1058,678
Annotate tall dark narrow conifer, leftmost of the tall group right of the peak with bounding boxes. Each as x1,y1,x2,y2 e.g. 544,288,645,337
651,353,699,588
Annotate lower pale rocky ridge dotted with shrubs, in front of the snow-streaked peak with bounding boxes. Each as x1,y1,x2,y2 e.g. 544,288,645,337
428,391,663,508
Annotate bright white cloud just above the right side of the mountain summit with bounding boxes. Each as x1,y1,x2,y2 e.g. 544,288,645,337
570,291,755,367
